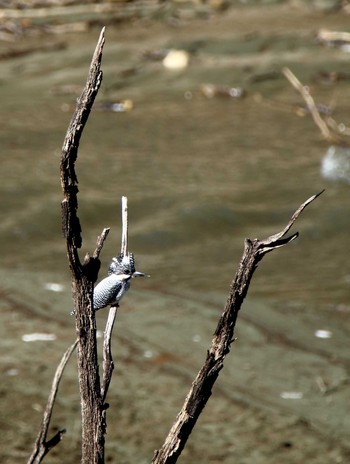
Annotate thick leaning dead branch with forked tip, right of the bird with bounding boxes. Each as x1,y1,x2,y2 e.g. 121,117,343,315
152,192,322,464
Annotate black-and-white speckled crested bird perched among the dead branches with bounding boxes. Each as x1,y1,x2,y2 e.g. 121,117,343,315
93,253,145,311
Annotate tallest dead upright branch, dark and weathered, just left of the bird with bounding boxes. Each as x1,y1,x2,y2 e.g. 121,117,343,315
61,28,106,464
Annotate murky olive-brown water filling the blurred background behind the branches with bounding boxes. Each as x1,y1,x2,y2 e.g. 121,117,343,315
0,2,350,464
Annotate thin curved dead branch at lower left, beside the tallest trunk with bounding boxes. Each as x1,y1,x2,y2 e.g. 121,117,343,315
27,340,78,464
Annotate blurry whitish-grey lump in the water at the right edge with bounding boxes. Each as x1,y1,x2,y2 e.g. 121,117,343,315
321,145,350,183
